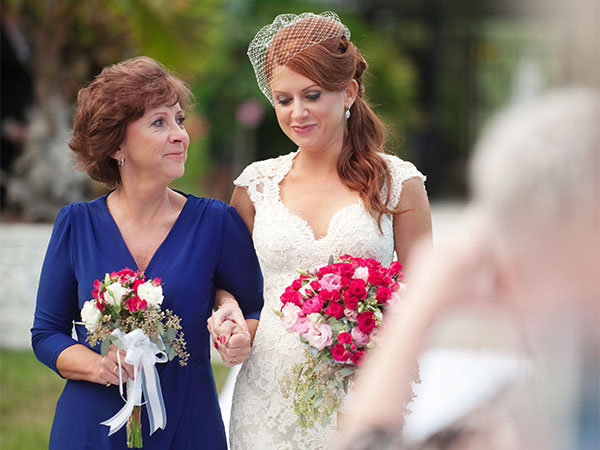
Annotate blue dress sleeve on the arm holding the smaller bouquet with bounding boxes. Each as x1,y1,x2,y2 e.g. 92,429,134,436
31,205,79,375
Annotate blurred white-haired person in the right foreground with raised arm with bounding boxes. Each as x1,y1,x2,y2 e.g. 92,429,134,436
344,88,600,450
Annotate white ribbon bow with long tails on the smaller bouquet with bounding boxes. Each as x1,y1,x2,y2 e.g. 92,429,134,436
100,328,169,436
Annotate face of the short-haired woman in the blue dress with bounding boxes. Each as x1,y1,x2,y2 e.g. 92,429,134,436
114,103,190,183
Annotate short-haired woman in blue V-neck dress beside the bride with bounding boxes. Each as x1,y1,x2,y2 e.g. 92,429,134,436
32,57,263,449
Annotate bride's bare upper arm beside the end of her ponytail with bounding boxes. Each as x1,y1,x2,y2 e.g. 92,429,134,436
394,177,432,264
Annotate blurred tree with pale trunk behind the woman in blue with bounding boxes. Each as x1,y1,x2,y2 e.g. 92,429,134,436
3,0,223,220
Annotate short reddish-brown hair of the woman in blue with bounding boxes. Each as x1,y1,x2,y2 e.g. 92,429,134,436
69,56,192,186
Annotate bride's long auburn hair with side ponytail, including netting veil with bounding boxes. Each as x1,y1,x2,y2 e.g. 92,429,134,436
248,12,396,229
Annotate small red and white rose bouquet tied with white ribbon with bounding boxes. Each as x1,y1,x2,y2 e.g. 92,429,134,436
81,268,189,448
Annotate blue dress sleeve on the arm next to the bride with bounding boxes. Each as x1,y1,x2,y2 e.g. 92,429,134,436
215,206,263,320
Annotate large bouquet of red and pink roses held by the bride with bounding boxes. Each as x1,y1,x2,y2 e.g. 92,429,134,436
275,255,404,428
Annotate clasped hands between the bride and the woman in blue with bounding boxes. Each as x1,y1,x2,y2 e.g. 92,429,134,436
207,299,252,367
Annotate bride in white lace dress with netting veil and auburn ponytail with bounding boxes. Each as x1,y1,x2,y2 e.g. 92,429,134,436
212,12,431,449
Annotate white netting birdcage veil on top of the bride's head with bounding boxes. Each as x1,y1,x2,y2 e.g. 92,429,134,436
248,11,350,105
